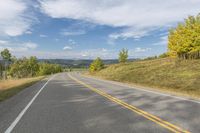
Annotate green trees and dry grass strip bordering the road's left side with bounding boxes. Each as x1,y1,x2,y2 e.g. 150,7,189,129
0,49,63,101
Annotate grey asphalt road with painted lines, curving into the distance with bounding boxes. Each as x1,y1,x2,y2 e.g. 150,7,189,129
0,73,200,133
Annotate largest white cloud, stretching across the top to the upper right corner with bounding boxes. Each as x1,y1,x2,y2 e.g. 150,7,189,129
40,0,200,40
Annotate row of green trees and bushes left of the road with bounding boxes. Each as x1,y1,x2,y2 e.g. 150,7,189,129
0,49,62,79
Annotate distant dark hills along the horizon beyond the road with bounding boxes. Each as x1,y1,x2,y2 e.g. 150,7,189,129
39,59,135,68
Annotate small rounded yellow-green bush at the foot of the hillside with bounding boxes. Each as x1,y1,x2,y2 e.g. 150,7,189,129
89,57,104,72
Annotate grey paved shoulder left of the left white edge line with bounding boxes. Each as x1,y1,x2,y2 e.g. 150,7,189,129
0,78,48,132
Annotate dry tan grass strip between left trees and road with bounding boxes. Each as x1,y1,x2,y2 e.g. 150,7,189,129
0,76,44,102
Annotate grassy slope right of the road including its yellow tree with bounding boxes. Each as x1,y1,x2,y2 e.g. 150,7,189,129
90,14,200,98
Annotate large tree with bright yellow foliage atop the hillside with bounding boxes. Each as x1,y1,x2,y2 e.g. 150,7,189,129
168,14,200,59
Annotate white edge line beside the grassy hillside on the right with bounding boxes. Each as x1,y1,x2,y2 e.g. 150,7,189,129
79,73,200,104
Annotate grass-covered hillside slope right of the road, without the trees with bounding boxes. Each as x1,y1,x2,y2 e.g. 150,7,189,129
94,58,200,97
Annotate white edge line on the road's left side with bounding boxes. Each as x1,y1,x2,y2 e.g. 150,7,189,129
4,75,55,133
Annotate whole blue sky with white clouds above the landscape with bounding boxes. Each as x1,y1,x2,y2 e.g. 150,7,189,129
0,0,200,59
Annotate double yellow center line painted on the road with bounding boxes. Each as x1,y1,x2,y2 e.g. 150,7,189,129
68,74,190,133
